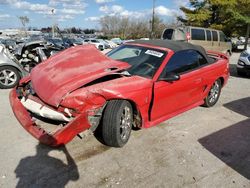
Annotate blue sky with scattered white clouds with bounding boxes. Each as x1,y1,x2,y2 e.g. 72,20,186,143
0,0,188,29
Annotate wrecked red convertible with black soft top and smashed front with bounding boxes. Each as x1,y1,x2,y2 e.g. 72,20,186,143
10,40,229,147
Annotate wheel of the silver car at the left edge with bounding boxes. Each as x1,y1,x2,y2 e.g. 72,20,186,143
0,66,21,89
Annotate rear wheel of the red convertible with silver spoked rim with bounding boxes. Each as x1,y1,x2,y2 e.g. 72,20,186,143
204,79,221,107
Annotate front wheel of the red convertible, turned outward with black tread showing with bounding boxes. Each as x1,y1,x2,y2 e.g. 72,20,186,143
101,100,133,147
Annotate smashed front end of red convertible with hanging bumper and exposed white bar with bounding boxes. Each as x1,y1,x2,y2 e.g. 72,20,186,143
10,81,106,146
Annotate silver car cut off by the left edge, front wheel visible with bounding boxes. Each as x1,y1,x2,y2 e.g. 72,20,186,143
0,45,28,89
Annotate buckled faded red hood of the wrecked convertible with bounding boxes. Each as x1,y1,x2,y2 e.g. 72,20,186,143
31,45,130,106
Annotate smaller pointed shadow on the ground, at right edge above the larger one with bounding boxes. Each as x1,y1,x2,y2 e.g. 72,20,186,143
223,97,250,118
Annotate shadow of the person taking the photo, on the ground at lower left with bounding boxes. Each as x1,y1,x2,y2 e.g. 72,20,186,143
15,144,79,188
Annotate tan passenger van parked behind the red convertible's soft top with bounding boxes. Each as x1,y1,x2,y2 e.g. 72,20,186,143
162,26,232,55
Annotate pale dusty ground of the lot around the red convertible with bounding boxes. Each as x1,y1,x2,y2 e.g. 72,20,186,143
0,54,250,188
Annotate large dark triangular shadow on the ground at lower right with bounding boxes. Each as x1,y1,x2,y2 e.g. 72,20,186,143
198,118,250,179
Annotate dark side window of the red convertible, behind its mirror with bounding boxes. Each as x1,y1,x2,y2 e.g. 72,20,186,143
161,50,207,76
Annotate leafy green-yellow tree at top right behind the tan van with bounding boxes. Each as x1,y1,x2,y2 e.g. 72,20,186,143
178,0,250,41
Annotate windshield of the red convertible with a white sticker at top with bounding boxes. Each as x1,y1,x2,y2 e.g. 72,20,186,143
107,45,166,78
